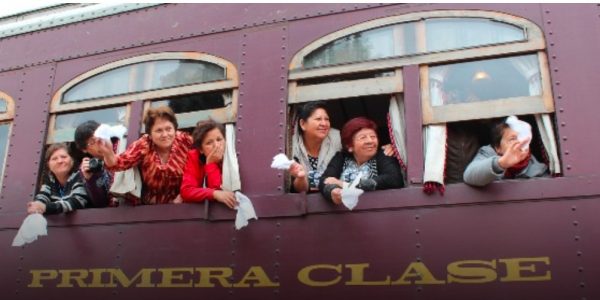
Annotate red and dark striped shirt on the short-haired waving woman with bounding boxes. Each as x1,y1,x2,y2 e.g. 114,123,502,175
108,131,192,204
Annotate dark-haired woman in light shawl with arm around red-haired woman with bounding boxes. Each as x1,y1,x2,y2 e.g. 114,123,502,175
289,101,394,192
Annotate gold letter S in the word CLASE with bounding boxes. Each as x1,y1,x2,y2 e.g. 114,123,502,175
447,260,498,283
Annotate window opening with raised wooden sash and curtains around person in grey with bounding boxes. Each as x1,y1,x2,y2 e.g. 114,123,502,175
420,51,561,186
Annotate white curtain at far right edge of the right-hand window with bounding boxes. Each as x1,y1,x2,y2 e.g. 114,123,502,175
511,55,561,174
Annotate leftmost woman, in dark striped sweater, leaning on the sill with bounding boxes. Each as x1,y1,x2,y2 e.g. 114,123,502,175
27,144,89,214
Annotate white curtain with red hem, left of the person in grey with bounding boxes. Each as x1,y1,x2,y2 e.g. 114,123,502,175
423,67,448,193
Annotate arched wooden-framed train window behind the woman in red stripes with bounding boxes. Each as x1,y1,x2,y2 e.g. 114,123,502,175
40,52,241,209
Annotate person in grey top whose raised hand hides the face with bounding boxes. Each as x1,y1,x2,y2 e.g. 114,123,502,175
463,119,548,186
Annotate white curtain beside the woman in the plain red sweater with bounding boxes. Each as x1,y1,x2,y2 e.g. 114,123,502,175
222,124,242,192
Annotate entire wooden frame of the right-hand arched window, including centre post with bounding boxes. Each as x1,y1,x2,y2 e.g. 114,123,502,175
288,10,555,191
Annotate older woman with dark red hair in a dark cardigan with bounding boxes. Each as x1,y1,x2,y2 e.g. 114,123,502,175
319,117,404,204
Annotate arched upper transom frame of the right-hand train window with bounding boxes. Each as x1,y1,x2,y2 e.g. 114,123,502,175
289,10,546,80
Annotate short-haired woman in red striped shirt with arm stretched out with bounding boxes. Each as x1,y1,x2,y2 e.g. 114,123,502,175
100,106,192,204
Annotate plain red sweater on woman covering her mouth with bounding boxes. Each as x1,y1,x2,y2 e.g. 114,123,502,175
180,149,222,202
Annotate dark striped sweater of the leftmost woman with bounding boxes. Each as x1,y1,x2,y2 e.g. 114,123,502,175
34,172,89,214
